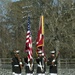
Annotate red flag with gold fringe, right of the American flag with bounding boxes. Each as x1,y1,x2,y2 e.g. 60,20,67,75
36,16,44,53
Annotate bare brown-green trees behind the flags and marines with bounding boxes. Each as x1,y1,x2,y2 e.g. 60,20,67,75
0,0,75,59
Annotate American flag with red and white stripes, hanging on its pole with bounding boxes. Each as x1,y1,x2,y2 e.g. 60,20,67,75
25,17,32,61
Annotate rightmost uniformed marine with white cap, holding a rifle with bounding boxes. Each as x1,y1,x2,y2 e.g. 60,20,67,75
47,51,57,75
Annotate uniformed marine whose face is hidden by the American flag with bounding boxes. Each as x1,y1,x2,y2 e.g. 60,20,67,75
24,57,34,75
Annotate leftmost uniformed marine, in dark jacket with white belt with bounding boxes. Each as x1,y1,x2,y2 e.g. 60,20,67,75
12,50,23,75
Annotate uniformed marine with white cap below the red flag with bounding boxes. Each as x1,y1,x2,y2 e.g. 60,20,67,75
36,51,46,75
